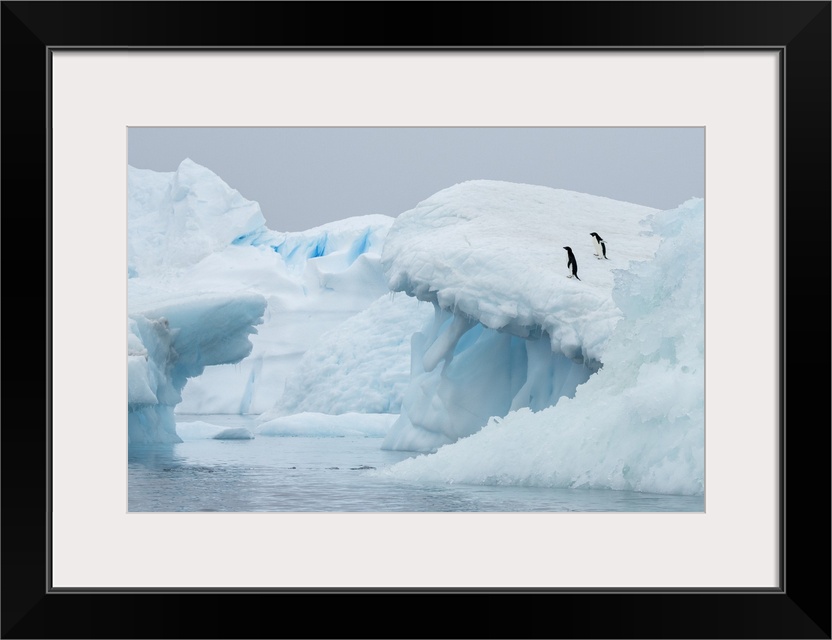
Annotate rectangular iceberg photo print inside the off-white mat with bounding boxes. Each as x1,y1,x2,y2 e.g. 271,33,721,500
125,122,708,514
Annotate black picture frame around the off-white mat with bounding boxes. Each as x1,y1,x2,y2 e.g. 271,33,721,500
0,1,832,638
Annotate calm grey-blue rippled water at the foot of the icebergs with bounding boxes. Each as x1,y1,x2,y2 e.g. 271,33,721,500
128,416,704,513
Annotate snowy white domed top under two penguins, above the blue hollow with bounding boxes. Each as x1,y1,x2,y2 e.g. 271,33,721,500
382,180,656,361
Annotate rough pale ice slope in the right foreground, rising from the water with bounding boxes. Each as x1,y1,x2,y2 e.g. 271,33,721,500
379,199,705,495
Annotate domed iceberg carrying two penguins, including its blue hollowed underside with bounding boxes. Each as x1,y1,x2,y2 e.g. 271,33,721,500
382,180,657,451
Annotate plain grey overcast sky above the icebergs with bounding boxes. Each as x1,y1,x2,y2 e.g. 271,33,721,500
128,127,705,231
